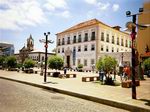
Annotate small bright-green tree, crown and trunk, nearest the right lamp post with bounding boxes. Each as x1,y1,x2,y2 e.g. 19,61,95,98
96,56,117,84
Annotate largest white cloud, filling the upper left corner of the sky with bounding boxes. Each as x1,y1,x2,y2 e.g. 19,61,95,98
0,0,47,30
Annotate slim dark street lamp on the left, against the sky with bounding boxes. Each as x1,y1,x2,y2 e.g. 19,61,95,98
39,32,54,82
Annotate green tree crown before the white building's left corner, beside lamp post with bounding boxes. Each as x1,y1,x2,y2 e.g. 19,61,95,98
48,55,64,70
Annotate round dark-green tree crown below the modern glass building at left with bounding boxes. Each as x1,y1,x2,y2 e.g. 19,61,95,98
6,56,17,68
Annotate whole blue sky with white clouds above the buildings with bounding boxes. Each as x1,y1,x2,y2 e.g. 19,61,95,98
0,0,150,53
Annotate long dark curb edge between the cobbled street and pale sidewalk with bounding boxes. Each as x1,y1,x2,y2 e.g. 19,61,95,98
0,76,150,112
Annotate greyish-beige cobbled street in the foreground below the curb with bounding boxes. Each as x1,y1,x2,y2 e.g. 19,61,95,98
0,79,127,112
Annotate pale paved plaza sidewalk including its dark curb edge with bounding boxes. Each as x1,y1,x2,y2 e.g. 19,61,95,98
0,70,150,112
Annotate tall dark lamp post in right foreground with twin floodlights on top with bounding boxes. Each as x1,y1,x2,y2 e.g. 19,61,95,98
126,8,143,99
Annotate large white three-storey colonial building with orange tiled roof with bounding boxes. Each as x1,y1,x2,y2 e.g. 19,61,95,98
56,19,131,70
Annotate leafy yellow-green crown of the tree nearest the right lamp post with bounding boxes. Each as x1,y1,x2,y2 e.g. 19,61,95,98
96,56,117,73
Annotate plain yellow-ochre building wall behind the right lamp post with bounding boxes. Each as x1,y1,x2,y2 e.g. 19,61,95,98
136,2,150,59
